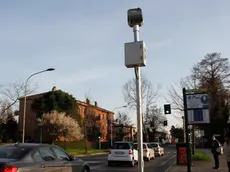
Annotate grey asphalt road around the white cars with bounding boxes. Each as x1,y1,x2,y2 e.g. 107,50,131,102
81,145,176,172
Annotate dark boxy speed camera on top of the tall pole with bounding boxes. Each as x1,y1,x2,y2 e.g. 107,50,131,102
128,8,143,27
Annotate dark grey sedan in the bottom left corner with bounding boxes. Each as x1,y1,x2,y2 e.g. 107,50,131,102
0,143,90,172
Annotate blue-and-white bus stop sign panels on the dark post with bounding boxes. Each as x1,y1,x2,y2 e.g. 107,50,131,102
186,93,210,125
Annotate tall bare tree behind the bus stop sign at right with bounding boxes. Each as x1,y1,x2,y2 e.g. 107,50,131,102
166,53,230,142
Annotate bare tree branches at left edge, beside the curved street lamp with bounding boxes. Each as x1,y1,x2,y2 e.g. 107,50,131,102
0,81,36,119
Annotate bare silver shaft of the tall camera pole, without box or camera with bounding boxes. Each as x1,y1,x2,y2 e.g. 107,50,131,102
133,25,144,172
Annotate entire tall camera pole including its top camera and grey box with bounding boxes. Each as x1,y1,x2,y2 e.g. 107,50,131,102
125,8,146,172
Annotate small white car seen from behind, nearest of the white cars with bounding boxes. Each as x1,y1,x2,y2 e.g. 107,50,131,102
108,141,138,167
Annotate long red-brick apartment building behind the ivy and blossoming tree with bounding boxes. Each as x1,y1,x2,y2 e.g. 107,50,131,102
19,87,114,142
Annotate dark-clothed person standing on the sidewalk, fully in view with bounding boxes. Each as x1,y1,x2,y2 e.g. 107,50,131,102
211,135,220,169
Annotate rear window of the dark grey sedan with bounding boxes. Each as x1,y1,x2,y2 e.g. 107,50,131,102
0,146,30,159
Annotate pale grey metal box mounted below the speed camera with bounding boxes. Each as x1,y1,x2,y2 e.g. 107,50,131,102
125,41,146,68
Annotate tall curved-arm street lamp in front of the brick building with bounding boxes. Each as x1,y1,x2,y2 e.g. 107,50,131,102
22,68,55,143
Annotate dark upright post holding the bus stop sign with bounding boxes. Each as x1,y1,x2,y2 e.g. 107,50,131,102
183,88,191,172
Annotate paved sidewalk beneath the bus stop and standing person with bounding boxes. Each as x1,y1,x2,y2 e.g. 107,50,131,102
167,150,228,172
